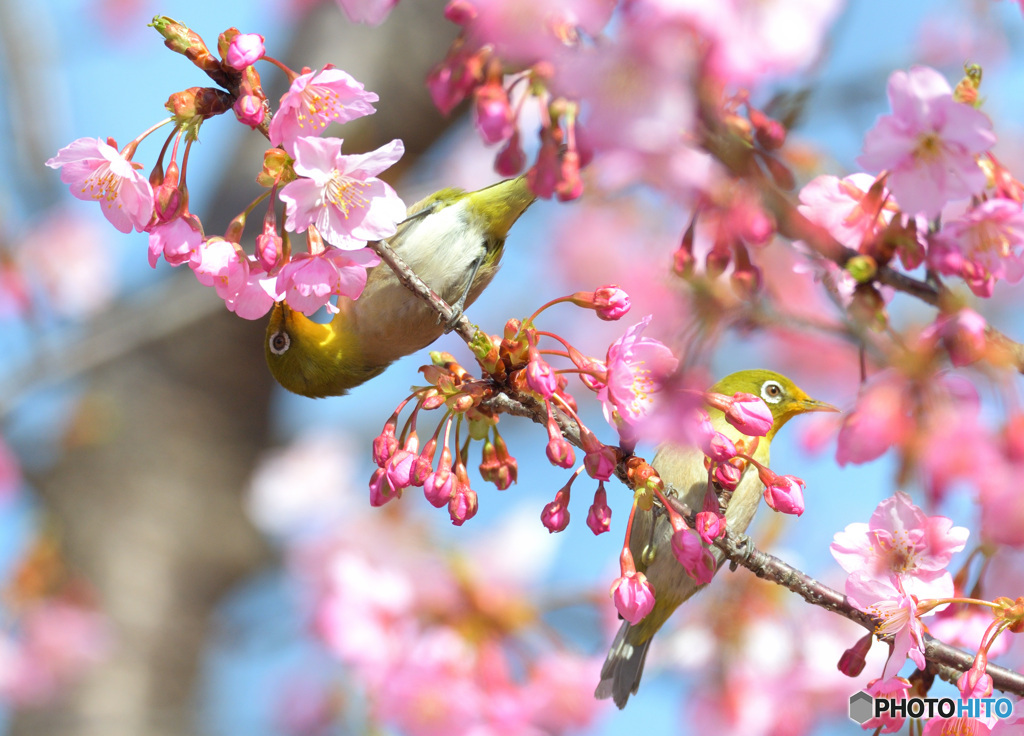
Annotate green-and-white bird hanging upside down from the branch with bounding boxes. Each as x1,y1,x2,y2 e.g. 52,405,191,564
265,176,537,398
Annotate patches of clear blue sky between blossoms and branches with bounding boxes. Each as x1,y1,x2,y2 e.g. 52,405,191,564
8,0,1024,736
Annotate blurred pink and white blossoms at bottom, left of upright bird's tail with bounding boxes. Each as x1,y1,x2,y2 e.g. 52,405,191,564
244,433,600,736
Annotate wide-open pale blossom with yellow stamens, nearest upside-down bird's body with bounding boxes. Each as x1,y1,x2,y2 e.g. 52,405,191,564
280,137,406,250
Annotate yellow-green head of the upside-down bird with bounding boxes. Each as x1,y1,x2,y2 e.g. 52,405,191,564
265,302,387,398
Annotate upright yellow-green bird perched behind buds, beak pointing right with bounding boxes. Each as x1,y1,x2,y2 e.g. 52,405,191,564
594,370,839,708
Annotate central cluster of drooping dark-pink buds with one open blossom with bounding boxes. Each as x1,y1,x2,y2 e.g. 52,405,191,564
370,286,676,534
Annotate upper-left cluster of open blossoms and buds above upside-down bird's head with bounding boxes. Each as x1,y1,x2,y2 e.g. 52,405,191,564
46,17,406,319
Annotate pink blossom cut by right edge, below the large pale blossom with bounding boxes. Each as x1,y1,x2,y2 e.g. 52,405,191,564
928,199,1024,297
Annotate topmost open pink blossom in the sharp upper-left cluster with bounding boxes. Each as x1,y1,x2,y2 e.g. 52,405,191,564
269,66,378,153
